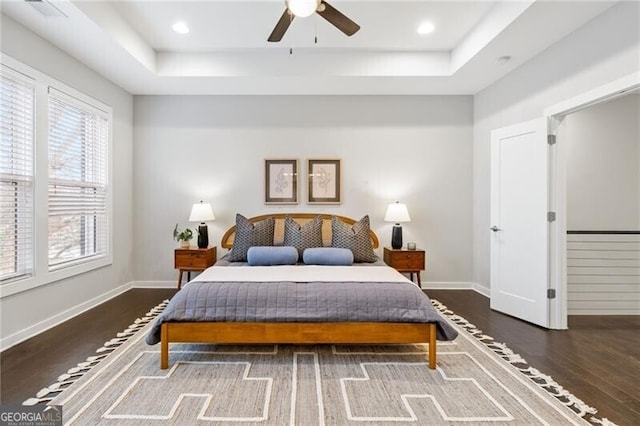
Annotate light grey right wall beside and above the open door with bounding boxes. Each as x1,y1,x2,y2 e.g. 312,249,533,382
473,2,640,287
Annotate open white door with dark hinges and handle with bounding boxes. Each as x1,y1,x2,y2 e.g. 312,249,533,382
490,119,549,327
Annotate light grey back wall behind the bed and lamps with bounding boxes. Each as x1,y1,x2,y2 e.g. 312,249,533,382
133,96,473,286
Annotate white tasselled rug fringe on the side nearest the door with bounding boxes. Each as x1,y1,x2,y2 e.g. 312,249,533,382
431,299,616,426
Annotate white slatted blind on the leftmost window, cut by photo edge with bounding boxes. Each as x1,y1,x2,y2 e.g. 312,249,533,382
0,67,35,283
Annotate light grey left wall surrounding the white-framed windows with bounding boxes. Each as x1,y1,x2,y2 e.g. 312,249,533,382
0,15,133,348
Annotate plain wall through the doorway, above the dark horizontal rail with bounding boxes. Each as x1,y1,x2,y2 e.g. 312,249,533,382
558,95,640,231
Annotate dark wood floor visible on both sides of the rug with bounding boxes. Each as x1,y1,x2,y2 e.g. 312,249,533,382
0,289,640,425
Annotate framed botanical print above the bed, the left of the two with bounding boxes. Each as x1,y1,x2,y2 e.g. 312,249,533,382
264,159,298,204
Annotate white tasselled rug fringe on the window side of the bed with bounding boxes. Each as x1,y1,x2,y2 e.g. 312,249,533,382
22,299,169,405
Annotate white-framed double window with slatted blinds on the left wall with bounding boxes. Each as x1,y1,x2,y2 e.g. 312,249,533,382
0,55,113,299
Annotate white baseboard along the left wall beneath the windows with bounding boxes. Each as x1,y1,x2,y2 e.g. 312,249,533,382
0,282,132,352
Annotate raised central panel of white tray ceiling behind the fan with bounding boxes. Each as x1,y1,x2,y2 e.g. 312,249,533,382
107,0,495,52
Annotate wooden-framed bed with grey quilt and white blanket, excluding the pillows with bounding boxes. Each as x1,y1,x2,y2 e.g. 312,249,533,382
146,213,457,369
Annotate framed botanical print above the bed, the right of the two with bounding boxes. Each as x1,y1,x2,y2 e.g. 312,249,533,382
307,159,342,204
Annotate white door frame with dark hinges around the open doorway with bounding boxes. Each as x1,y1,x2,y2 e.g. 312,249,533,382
544,73,640,330
